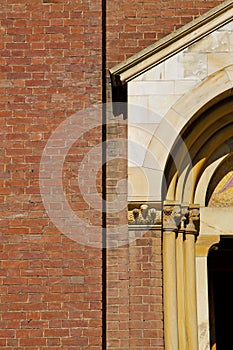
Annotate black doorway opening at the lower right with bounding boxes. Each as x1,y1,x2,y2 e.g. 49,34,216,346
208,236,233,350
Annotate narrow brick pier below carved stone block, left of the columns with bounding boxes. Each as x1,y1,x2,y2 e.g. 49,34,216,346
129,231,164,350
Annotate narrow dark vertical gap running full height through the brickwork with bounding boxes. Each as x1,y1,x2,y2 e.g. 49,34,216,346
102,0,107,350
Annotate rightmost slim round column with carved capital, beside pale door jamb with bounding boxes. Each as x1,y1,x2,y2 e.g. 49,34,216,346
184,205,199,350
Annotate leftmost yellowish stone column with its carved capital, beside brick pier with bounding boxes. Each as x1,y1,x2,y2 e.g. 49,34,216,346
163,204,180,350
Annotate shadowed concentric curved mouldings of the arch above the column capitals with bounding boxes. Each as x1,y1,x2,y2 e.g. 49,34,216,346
162,96,233,203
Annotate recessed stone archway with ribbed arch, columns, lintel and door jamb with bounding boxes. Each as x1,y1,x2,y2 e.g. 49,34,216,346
163,92,233,350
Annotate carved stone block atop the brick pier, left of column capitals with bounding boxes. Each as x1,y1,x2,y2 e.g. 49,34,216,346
128,203,161,226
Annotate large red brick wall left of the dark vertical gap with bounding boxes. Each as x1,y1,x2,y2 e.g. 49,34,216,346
0,0,102,350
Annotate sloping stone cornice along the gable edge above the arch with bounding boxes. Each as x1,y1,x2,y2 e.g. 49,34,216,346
110,0,233,102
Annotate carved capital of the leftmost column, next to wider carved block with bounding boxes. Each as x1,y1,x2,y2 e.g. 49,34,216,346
163,204,181,231
